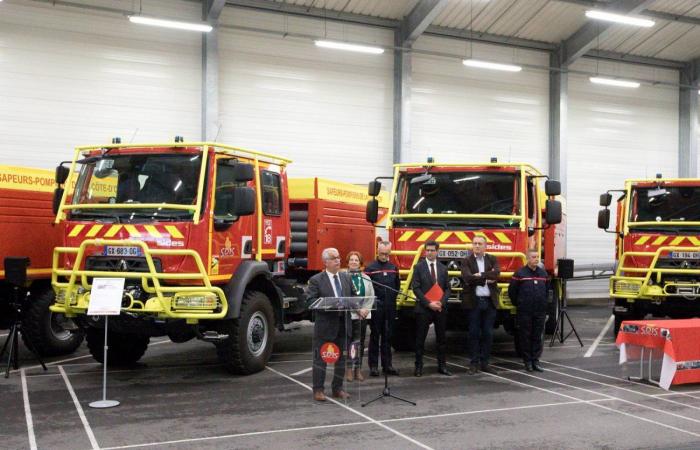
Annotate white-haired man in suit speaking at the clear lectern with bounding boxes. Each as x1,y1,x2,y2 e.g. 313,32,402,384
307,248,354,402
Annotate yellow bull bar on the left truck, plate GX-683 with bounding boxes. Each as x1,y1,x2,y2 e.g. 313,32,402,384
51,239,228,324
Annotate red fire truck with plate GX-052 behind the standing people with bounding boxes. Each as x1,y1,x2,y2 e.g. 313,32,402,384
367,159,565,350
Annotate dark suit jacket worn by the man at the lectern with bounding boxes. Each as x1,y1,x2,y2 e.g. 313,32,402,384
307,270,355,341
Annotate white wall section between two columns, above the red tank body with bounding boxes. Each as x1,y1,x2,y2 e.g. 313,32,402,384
219,8,393,184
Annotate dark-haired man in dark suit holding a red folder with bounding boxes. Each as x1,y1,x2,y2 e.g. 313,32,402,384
411,241,452,377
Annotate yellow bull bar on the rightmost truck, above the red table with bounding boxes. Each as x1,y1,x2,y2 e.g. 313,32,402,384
609,246,700,299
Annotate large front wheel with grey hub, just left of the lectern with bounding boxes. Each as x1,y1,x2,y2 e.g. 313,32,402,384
216,291,275,375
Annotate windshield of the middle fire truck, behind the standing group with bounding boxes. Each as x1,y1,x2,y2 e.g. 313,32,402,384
394,171,520,222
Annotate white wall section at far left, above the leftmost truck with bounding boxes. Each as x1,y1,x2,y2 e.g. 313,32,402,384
0,1,201,168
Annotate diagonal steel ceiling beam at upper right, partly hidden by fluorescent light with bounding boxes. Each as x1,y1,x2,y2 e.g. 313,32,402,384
562,0,654,66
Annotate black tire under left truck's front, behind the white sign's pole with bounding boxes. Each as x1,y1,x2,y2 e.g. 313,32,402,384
87,327,151,366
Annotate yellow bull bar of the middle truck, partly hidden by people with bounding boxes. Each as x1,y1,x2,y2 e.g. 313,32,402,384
391,244,527,311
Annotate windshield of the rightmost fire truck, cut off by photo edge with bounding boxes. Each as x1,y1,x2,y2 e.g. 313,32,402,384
629,186,700,223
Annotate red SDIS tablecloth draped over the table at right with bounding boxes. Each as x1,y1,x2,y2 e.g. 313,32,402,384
615,319,700,389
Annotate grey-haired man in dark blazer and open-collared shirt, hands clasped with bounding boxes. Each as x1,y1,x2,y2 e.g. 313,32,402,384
462,236,501,375
